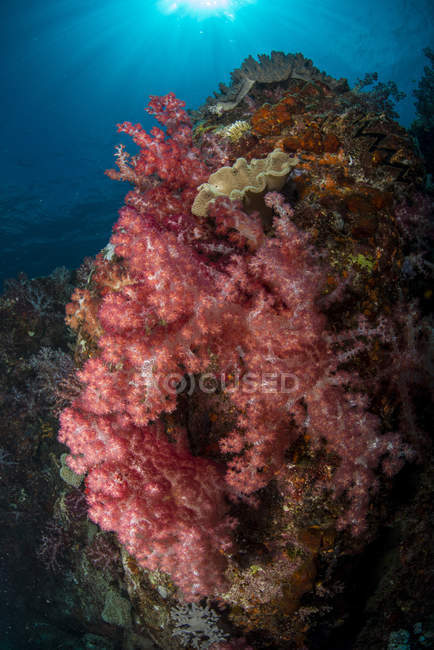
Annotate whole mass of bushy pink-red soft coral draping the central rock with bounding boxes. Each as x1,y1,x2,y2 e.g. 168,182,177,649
59,94,410,600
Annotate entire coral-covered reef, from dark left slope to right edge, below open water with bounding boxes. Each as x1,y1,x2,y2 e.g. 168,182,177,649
0,53,434,650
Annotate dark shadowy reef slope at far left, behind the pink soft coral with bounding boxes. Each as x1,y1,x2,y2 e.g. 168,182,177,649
0,268,159,650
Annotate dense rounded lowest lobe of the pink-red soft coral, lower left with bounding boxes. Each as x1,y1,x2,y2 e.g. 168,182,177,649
60,408,235,600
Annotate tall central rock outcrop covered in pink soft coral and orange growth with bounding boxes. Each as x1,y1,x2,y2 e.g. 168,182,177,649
59,54,430,636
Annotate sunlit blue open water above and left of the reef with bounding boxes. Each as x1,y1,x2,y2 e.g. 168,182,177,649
0,0,434,280
